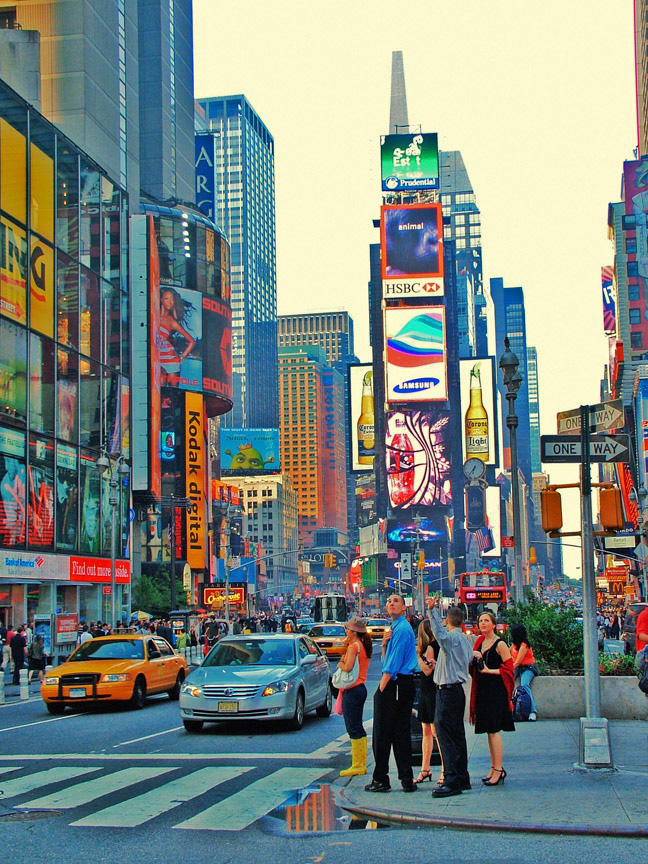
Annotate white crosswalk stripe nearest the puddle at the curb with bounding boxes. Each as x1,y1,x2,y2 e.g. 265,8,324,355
173,766,331,831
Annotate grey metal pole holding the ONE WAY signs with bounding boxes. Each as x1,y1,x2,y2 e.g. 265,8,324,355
580,405,601,719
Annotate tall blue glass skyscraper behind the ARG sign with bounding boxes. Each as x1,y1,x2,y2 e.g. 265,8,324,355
198,96,279,428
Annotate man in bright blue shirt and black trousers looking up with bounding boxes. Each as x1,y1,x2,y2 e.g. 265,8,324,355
365,594,418,792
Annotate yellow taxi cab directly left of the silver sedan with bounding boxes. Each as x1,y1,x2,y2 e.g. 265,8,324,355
41,633,189,714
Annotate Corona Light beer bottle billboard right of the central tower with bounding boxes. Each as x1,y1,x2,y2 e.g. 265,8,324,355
459,357,499,467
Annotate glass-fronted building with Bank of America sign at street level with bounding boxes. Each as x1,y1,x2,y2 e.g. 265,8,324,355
0,81,130,632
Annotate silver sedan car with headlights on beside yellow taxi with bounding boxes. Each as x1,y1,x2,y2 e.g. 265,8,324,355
180,633,333,732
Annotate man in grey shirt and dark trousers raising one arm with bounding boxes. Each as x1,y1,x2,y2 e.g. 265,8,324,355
427,594,473,798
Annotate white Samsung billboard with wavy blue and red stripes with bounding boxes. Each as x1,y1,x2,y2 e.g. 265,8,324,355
385,306,448,403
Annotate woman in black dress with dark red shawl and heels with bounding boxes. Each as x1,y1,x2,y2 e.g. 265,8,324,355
470,612,515,786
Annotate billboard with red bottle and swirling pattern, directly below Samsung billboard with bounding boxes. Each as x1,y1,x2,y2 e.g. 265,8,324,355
385,410,452,510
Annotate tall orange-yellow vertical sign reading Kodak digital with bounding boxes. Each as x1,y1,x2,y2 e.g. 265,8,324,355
185,392,206,570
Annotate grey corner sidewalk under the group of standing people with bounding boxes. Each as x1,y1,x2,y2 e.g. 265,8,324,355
339,720,648,837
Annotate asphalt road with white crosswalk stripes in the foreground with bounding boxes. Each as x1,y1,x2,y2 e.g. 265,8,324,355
0,663,645,864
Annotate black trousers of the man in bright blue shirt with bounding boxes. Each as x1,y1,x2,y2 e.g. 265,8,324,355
372,675,415,784
